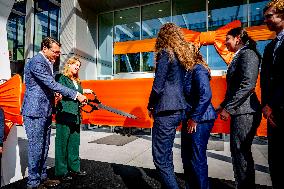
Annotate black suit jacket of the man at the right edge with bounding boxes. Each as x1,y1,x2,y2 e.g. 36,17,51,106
260,37,284,120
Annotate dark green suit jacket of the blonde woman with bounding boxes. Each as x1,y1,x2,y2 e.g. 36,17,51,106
55,74,83,124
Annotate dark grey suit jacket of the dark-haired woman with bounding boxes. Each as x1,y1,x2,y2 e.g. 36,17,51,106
221,47,261,115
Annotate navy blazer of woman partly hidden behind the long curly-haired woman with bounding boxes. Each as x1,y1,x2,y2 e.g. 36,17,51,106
184,64,217,123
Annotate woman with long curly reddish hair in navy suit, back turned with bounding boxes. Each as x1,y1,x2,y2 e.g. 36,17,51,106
148,23,189,189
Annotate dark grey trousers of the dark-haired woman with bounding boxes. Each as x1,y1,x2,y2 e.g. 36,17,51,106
230,112,261,189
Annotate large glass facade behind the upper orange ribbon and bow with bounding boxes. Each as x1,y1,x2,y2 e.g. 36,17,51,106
98,0,269,74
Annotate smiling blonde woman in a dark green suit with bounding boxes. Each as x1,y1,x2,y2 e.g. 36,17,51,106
55,57,92,181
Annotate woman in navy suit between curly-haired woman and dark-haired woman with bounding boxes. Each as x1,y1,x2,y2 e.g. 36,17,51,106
181,43,217,189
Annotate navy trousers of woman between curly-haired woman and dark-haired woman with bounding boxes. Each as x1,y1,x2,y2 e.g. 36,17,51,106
181,120,215,189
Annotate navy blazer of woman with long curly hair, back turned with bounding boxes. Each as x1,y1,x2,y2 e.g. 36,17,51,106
148,50,186,113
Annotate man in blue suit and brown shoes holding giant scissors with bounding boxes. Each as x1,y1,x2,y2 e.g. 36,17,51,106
22,37,86,188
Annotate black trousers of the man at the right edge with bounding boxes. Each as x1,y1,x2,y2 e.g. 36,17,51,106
267,117,284,189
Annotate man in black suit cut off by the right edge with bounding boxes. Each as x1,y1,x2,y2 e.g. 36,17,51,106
260,0,284,189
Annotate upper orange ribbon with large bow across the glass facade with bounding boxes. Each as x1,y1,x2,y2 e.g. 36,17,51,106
114,20,275,64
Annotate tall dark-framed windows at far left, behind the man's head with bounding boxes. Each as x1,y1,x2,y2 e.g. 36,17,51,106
7,0,61,78
